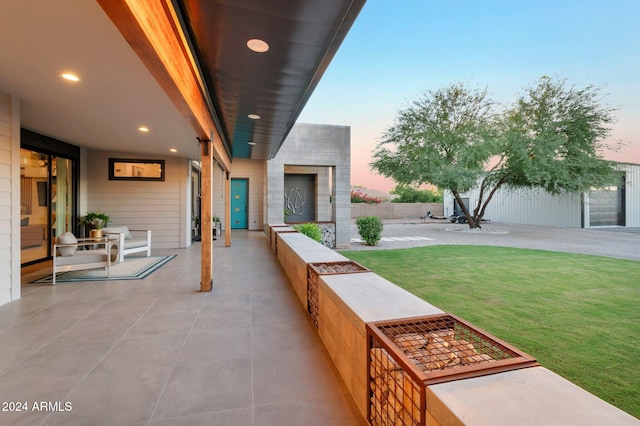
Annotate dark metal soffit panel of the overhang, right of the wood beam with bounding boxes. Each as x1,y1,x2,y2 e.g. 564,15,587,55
173,0,364,159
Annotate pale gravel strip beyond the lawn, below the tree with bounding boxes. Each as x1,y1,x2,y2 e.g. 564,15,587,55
344,219,640,260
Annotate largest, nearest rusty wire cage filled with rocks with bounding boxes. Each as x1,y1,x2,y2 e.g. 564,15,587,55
367,314,538,425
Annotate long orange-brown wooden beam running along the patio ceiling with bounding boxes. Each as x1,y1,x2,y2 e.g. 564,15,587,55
98,0,231,172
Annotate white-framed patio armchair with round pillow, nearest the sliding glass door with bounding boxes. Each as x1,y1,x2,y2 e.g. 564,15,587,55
52,232,112,285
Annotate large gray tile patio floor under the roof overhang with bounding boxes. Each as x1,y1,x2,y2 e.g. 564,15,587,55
0,231,366,426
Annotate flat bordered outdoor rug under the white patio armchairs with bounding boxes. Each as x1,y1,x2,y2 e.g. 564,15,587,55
29,255,176,284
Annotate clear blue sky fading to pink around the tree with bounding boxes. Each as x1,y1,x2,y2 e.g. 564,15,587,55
298,0,640,191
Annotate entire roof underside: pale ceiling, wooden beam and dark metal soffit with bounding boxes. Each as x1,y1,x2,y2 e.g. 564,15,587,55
0,0,364,166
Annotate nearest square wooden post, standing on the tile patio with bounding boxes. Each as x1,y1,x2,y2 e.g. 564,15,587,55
198,139,213,291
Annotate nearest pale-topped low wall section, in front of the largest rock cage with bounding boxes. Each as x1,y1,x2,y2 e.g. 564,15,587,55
427,367,640,426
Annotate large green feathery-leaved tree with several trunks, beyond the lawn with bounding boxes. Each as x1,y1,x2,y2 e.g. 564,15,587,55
370,77,614,228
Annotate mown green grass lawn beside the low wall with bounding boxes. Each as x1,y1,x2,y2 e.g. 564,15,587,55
341,245,640,418
